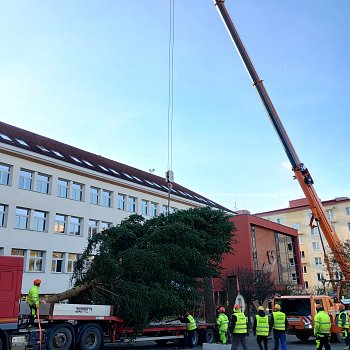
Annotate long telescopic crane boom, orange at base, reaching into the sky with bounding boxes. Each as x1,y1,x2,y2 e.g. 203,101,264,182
214,0,350,286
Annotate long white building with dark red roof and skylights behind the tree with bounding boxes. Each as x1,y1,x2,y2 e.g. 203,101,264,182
0,122,233,294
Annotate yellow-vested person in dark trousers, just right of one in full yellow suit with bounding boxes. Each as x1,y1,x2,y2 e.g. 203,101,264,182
231,304,249,350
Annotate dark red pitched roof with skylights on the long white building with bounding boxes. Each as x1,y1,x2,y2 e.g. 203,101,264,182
0,121,234,213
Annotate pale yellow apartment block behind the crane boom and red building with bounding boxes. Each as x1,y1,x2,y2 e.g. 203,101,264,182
255,197,350,290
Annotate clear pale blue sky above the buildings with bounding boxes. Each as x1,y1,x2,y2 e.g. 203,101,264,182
0,0,350,213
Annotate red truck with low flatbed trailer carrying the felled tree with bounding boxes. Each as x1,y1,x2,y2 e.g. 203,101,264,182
0,256,215,350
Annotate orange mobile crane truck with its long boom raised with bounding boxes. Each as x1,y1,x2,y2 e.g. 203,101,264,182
214,0,350,340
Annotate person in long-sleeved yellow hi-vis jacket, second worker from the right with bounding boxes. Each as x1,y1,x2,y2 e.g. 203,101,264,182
314,304,331,350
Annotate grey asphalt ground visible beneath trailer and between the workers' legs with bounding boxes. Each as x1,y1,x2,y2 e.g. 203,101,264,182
105,335,345,350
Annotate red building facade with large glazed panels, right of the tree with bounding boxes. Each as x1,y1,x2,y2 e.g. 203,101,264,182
214,214,303,292
